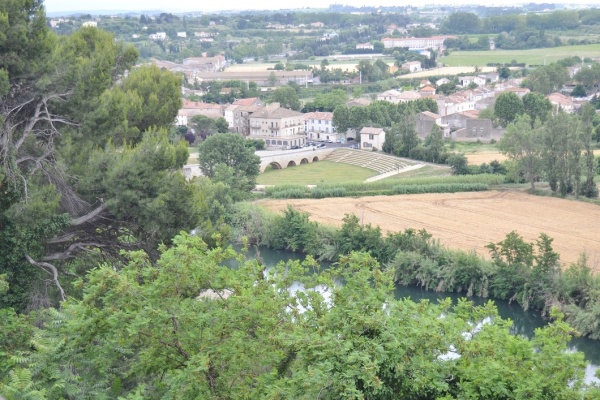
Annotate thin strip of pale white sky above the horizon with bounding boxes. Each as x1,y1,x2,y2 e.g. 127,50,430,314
44,0,596,12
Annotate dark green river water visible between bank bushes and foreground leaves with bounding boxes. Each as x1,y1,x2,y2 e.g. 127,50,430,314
238,247,600,384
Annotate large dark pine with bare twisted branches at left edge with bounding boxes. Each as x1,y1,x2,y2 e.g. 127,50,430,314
0,10,198,310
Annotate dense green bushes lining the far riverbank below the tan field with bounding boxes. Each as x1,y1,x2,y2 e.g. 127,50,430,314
233,204,600,339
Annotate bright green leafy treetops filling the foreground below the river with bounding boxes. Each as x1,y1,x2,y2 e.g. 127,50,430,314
0,234,585,399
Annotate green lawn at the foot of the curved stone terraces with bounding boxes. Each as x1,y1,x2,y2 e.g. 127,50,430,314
257,161,377,185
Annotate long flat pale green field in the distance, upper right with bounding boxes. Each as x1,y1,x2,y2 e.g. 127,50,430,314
439,44,600,66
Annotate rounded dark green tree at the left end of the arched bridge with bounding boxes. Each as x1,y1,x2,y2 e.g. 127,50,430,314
198,133,262,199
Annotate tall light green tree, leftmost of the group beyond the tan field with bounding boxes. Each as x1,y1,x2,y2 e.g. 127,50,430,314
498,115,543,192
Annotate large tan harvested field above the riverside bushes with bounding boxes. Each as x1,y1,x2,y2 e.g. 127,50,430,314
259,191,600,272
